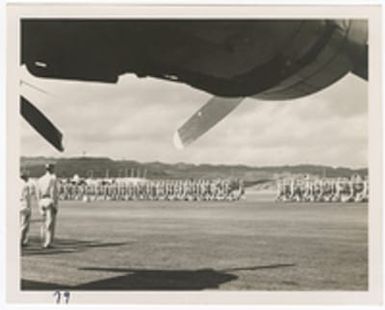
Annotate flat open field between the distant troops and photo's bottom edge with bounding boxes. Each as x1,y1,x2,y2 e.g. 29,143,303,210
21,197,368,291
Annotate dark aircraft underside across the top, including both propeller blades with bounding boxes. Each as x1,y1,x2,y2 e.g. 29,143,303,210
21,19,368,150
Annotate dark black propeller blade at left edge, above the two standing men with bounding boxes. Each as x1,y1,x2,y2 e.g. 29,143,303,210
20,96,64,152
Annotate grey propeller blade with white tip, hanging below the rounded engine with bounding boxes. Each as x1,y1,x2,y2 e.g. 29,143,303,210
174,97,243,149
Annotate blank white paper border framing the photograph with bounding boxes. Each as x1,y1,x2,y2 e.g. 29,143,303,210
5,3,383,305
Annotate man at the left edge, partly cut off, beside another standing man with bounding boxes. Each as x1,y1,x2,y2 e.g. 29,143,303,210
20,171,32,247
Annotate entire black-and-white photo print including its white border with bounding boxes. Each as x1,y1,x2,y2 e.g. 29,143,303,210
7,5,382,304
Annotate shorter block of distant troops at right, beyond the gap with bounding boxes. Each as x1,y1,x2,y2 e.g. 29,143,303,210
276,175,369,202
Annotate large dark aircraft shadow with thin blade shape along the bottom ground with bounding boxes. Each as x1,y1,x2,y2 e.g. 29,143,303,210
21,264,295,291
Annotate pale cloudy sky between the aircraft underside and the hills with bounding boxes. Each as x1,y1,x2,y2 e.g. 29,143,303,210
21,64,368,168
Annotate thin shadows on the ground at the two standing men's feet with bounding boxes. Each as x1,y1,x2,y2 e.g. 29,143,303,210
21,238,127,256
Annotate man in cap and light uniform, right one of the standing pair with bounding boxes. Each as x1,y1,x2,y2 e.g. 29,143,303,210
37,164,59,248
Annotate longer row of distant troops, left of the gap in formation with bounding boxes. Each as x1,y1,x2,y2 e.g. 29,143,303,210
59,179,245,202
